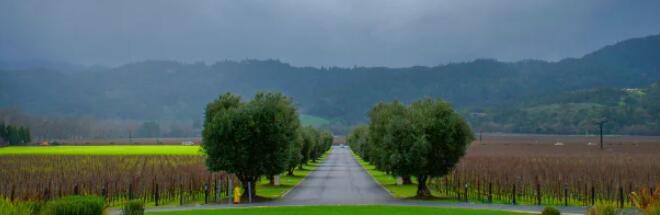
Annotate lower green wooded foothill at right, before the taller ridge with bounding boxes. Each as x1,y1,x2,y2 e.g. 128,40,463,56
464,83,660,135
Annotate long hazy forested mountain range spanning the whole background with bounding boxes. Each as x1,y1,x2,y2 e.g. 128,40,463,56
0,35,660,134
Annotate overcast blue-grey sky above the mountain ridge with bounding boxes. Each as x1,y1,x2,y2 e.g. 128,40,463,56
0,0,660,67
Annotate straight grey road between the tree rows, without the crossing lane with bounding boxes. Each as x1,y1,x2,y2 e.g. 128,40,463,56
280,147,394,205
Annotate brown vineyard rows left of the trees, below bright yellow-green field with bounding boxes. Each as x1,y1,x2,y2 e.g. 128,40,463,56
0,155,228,205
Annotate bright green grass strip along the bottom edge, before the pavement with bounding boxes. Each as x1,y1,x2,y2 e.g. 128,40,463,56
146,205,525,215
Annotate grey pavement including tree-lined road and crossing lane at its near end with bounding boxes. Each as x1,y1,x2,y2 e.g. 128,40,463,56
111,146,587,214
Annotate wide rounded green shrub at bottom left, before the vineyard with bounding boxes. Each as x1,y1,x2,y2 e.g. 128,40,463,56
42,196,105,215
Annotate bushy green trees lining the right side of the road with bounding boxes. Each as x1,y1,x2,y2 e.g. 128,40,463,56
348,99,474,198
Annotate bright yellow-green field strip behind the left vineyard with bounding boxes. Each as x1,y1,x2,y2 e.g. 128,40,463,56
0,145,203,156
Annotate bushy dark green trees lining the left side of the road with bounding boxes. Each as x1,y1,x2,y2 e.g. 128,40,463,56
202,92,332,197
